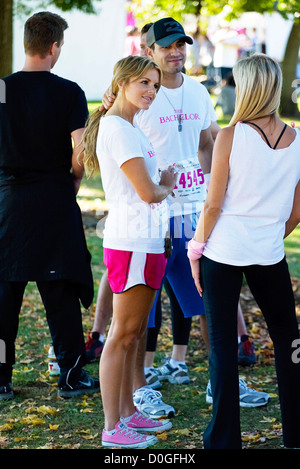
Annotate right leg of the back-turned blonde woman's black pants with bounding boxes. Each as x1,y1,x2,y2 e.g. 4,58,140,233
245,259,300,448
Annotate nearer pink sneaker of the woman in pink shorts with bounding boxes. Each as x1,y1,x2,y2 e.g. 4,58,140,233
102,421,158,449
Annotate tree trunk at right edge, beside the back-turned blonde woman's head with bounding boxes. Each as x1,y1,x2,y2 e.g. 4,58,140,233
280,22,300,118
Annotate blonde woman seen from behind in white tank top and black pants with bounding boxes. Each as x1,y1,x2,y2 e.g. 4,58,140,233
188,54,300,449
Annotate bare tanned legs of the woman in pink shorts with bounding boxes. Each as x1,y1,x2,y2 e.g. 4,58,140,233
100,285,155,431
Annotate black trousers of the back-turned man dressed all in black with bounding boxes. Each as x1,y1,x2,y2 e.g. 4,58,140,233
0,280,85,385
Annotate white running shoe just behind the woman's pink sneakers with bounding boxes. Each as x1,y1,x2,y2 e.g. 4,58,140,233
133,386,175,419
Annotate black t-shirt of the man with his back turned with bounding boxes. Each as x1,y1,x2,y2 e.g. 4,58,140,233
0,72,87,173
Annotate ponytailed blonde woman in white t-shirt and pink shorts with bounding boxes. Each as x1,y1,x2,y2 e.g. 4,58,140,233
84,56,177,448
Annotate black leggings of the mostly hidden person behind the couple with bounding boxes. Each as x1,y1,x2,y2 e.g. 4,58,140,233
146,279,192,352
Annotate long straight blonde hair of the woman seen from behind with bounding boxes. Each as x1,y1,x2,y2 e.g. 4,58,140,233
229,54,282,126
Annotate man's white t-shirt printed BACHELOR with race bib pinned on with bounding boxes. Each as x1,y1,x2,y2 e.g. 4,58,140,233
135,75,212,216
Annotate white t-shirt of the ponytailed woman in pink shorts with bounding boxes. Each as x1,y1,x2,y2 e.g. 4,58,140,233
96,116,168,253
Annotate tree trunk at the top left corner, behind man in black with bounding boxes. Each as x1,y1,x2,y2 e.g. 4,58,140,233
0,0,13,77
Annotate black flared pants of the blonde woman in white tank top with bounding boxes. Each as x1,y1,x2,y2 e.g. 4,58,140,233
200,256,300,449
